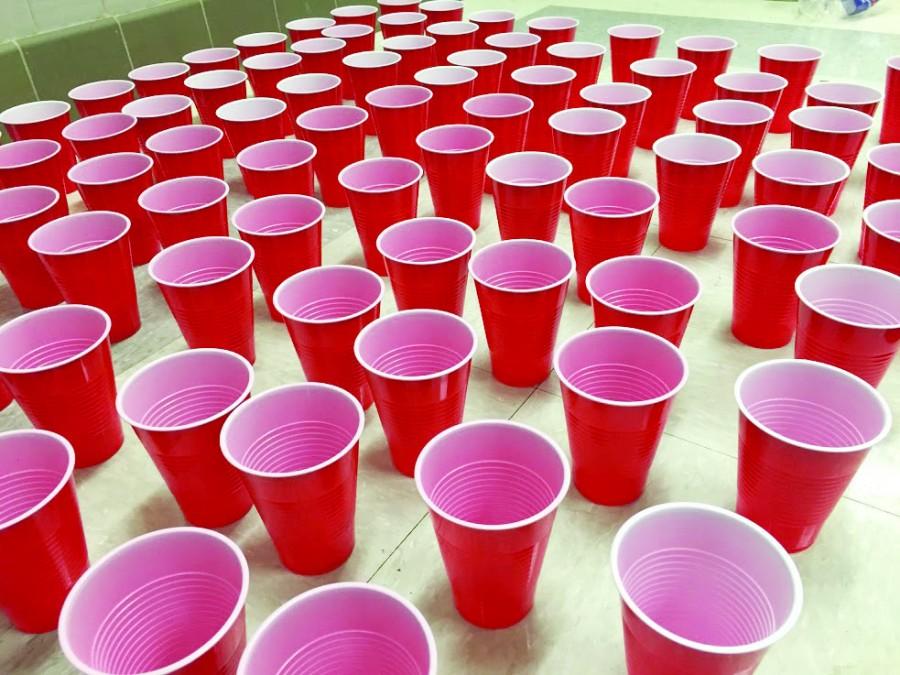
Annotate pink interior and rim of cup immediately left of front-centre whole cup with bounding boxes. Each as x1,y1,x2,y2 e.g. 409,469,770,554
222,382,363,475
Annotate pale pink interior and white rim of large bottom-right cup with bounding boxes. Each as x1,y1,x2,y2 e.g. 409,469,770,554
612,510,802,660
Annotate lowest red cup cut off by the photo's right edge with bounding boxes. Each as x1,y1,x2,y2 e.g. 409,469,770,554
794,265,900,387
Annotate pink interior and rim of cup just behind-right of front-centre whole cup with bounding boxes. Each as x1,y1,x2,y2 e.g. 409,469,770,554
554,328,687,405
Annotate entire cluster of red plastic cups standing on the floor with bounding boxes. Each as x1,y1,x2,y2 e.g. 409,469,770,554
0,0,900,675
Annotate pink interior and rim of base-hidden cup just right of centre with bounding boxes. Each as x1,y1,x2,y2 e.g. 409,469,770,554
587,255,700,314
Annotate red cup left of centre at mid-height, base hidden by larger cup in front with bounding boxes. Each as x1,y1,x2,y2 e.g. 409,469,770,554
148,237,256,364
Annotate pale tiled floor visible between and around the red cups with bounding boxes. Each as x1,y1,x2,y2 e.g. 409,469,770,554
0,0,900,675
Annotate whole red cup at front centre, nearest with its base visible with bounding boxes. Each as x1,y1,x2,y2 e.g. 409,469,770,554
416,420,571,628
